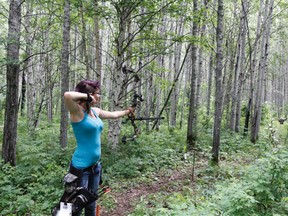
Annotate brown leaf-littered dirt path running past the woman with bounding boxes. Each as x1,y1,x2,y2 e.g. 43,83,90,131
101,166,200,216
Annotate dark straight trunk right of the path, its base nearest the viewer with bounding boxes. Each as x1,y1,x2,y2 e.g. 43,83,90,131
212,0,224,165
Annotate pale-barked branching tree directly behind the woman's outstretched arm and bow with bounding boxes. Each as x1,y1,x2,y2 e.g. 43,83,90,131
108,0,172,149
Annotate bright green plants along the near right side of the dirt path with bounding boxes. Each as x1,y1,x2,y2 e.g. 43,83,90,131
132,144,288,216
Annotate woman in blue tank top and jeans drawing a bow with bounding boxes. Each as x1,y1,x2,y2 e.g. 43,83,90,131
64,80,134,216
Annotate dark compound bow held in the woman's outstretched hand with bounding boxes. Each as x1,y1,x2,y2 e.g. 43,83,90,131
122,93,164,144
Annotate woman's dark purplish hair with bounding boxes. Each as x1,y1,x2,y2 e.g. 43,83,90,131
75,80,100,113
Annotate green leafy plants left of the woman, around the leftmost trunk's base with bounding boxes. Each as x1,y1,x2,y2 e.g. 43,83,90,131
0,121,71,215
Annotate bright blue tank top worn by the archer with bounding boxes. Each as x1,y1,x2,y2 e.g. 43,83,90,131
71,110,103,169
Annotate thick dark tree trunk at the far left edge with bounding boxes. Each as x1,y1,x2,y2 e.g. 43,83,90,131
2,0,22,166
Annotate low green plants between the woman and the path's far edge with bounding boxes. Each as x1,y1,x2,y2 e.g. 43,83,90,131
102,125,184,178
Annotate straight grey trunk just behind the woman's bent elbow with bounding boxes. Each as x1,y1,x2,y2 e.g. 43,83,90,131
60,0,70,148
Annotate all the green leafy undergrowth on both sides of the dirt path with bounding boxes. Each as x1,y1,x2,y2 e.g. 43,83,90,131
0,117,288,216
